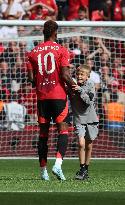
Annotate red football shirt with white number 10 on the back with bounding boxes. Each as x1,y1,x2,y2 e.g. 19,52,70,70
27,41,69,100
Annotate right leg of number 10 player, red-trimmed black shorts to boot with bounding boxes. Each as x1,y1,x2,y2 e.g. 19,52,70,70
52,100,68,180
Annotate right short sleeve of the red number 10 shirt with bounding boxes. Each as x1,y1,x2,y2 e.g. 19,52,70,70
61,47,70,67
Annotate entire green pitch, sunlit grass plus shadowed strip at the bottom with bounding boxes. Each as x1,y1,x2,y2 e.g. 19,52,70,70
0,159,125,205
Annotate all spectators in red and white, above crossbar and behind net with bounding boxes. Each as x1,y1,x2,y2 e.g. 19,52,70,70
0,0,125,131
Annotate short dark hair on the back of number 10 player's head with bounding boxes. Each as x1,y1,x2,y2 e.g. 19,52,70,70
43,20,58,39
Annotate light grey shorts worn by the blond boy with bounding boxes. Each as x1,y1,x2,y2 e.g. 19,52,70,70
75,123,99,140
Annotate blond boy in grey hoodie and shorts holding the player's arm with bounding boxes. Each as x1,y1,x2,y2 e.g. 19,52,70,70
69,65,98,180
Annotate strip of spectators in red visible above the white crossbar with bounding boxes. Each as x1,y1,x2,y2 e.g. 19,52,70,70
0,0,125,21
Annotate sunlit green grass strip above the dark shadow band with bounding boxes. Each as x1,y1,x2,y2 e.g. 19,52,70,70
0,159,125,192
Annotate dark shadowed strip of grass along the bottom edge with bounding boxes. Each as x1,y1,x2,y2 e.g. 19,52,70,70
0,192,125,205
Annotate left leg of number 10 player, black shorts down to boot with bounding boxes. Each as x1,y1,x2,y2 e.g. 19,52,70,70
37,101,50,180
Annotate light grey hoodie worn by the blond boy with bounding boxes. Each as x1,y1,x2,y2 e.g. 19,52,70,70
69,79,98,125
